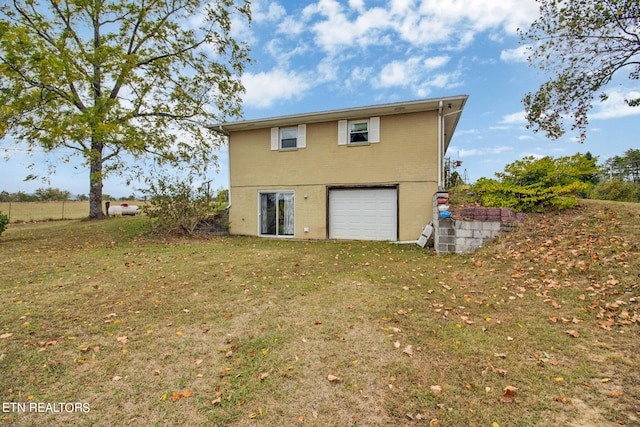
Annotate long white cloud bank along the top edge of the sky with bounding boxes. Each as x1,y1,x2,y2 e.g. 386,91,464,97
296,0,538,52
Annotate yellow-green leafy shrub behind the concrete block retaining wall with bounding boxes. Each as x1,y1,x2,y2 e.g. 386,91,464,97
473,153,600,212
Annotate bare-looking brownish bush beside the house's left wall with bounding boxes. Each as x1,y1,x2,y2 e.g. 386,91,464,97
142,177,224,235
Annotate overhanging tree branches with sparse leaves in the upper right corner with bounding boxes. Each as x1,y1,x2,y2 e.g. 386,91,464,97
521,0,640,141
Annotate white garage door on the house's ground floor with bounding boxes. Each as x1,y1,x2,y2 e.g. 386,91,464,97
329,188,398,240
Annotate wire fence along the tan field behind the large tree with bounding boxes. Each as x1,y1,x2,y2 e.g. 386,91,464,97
0,200,142,222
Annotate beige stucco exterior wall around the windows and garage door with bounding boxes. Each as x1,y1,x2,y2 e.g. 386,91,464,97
229,111,438,240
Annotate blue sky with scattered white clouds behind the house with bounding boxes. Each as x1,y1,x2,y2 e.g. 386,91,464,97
0,0,640,196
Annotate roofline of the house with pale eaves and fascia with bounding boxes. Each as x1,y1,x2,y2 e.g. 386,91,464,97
210,95,469,134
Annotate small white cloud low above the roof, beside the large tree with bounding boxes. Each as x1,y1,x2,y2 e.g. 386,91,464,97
242,69,311,108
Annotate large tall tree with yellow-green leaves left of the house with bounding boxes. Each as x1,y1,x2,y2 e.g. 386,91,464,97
0,0,251,217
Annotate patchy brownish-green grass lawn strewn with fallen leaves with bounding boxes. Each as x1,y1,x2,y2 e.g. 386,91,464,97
0,201,640,427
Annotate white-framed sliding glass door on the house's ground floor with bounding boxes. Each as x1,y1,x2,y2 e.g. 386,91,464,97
259,191,295,237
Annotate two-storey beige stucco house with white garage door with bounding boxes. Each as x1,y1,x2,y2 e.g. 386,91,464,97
218,95,467,241
